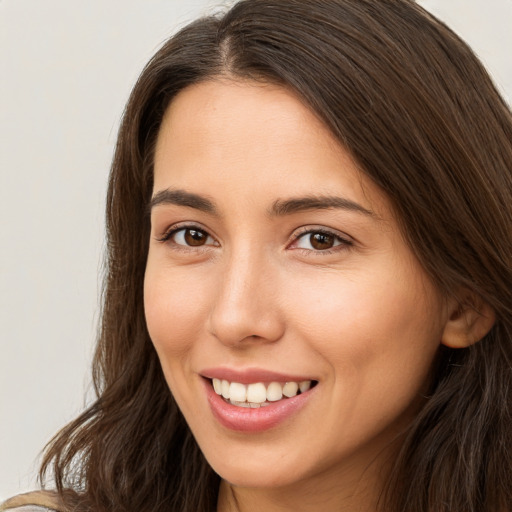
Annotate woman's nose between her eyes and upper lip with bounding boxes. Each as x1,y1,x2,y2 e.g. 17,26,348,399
209,248,284,348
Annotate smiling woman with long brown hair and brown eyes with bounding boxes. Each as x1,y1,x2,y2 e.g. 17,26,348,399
3,0,512,512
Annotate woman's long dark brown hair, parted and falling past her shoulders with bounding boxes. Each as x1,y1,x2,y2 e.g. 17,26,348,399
40,0,512,512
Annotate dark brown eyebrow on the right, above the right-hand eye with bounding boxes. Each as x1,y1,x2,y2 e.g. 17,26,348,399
269,196,377,217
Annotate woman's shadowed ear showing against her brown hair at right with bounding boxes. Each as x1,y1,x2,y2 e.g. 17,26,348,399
441,290,496,348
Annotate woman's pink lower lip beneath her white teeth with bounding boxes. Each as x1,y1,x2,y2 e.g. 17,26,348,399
204,379,316,432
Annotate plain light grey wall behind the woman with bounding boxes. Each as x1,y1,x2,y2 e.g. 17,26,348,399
0,0,512,500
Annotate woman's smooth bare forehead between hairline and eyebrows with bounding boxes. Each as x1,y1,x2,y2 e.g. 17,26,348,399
154,80,387,220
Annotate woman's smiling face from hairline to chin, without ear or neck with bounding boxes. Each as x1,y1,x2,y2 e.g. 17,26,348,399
145,80,448,487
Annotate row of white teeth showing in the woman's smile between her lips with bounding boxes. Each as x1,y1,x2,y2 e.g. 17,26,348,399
211,378,317,409
